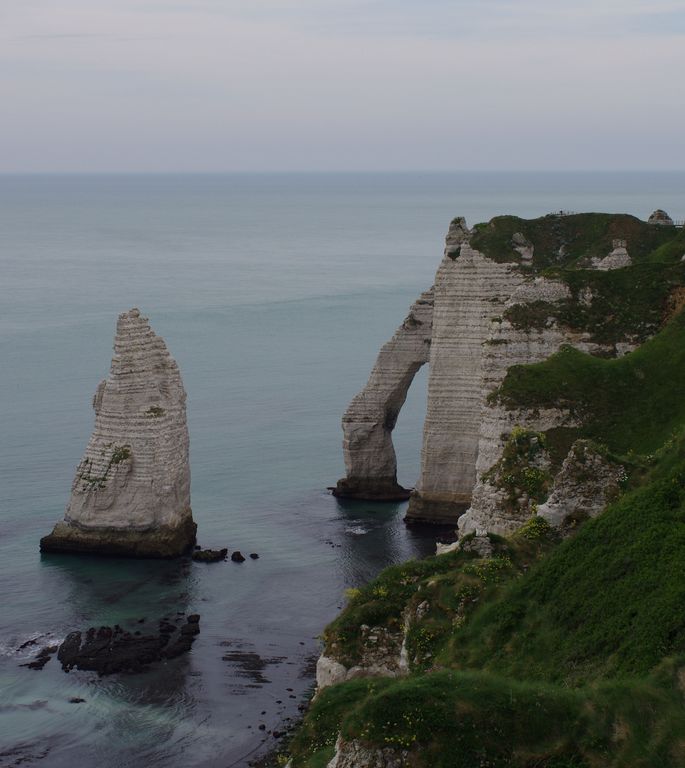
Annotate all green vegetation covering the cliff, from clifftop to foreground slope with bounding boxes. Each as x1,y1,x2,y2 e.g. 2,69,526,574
290,214,685,768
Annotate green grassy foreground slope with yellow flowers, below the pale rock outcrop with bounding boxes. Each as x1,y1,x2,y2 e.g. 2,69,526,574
291,426,685,768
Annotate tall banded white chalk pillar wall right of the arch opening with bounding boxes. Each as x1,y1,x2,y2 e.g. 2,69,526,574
406,219,523,523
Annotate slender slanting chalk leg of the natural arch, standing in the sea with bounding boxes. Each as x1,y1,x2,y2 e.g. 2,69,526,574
333,289,433,501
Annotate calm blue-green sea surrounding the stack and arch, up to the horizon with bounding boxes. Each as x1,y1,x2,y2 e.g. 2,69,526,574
0,173,685,768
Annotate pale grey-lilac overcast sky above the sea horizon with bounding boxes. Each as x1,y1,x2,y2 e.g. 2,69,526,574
0,0,685,173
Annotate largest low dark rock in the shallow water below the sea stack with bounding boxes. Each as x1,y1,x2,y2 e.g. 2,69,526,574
57,614,200,675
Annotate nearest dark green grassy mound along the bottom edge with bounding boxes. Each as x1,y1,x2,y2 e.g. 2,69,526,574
292,663,685,768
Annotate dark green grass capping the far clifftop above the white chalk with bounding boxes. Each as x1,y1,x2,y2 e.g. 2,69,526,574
471,213,685,344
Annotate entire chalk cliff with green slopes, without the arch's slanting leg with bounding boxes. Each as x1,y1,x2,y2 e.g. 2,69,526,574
289,211,685,768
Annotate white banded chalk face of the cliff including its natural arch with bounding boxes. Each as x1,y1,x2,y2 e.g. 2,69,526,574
334,214,653,536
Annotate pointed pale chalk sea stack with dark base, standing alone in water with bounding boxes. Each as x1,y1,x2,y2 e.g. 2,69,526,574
40,309,197,557
